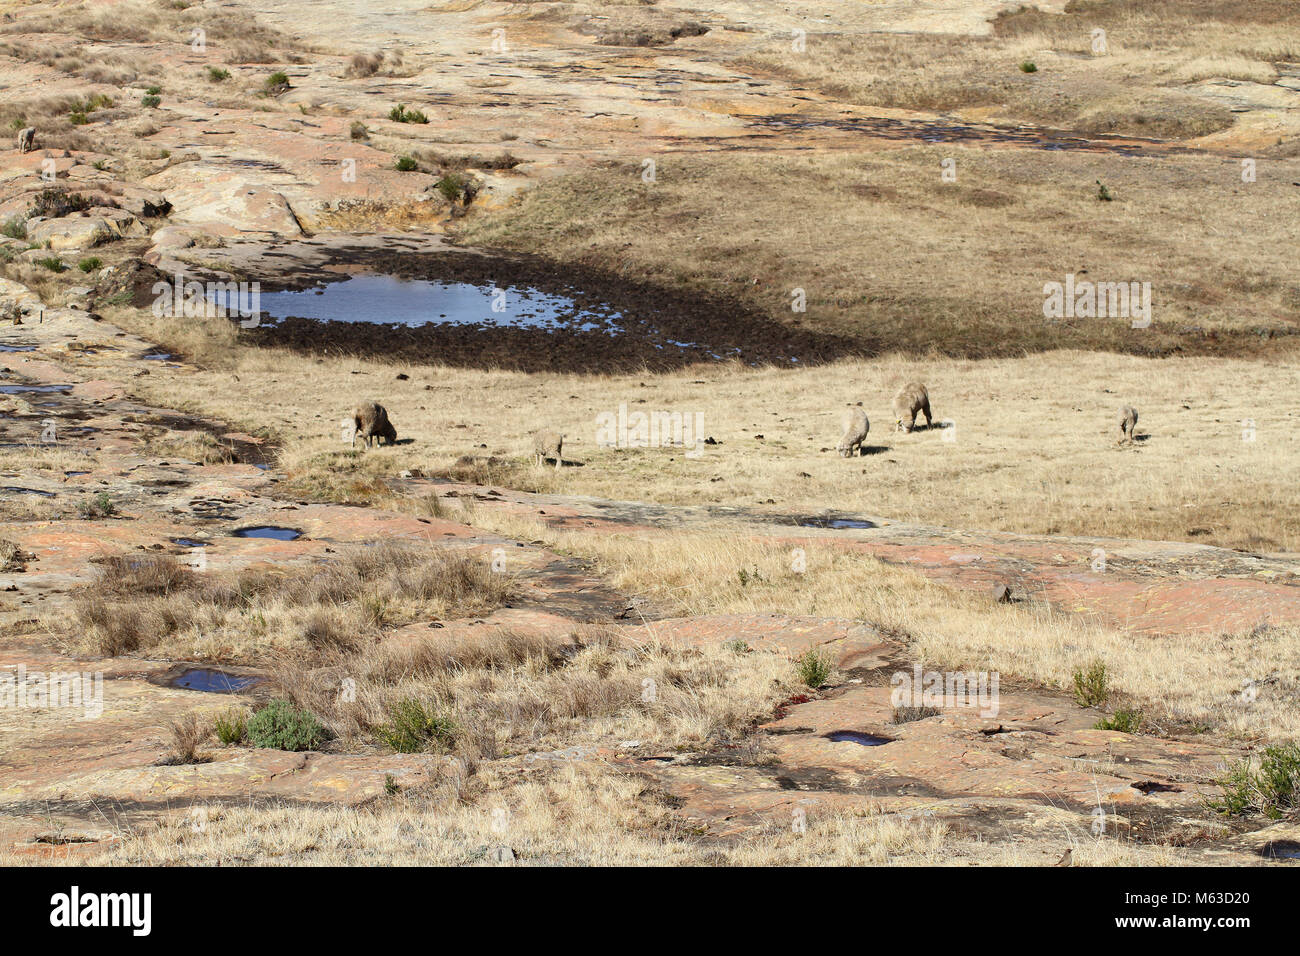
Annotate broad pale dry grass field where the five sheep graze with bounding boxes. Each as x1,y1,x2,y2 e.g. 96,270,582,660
109,325,1300,551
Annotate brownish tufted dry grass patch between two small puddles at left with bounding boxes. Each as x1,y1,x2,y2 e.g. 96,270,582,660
64,542,512,663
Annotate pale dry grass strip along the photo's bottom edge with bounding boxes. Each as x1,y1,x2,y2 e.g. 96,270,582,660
0,763,982,866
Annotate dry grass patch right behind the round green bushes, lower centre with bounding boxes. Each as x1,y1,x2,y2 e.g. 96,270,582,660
277,628,796,760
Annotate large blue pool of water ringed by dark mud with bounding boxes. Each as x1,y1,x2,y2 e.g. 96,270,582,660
208,276,623,334
